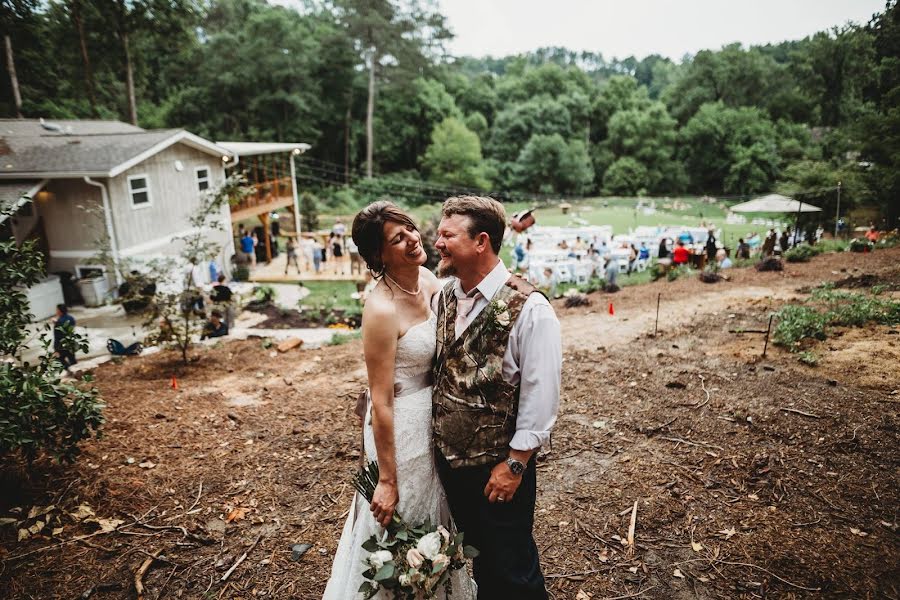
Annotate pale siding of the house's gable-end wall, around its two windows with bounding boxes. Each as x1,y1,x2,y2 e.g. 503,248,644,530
108,144,231,256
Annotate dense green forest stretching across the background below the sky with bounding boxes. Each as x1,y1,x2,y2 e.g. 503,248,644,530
0,0,900,228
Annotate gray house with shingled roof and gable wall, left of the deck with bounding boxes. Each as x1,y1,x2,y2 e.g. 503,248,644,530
0,119,234,298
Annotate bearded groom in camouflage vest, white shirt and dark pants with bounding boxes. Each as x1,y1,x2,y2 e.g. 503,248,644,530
433,196,562,600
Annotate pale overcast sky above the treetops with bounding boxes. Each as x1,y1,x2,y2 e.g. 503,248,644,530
438,0,885,60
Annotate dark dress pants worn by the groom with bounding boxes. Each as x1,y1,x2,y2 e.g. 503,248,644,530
434,449,547,600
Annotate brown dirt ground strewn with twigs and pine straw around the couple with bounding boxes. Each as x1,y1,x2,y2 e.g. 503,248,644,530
0,249,900,600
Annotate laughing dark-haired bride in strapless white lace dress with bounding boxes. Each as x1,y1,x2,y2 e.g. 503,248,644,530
324,201,475,600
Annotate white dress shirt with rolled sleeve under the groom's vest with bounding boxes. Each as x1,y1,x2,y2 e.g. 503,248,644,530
444,260,562,450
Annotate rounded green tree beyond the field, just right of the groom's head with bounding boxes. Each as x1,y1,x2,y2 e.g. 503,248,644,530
514,133,594,194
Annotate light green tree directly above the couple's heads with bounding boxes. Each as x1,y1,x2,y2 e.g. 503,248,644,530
422,117,491,190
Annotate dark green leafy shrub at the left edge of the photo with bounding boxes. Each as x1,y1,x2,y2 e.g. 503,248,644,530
0,206,103,463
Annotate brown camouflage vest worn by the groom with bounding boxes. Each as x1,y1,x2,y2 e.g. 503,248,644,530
432,276,536,468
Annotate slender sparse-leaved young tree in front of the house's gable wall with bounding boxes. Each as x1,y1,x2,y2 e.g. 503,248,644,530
144,175,251,365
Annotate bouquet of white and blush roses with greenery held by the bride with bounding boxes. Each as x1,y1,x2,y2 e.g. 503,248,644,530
353,461,478,600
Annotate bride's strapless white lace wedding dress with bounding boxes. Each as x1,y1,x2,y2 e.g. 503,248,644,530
324,314,475,600
